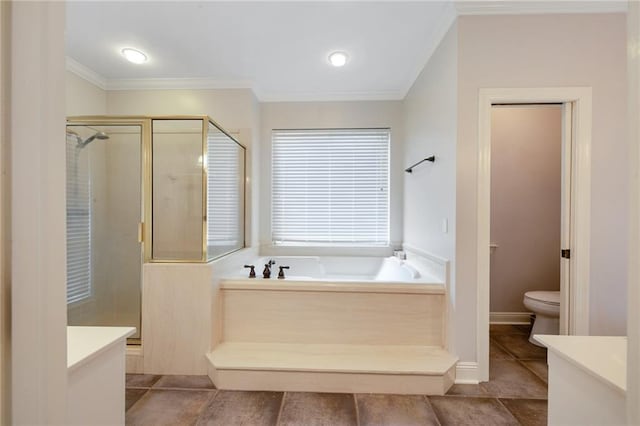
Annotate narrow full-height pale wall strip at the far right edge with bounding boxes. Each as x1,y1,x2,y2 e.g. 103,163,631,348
627,1,640,425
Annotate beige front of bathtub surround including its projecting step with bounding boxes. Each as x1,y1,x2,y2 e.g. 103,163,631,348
207,264,457,395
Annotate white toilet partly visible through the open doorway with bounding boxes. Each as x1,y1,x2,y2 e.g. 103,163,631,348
523,291,560,346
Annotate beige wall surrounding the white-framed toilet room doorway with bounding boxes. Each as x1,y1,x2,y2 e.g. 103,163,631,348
456,14,628,360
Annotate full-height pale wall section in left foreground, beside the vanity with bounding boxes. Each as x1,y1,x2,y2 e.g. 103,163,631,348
10,2,67,425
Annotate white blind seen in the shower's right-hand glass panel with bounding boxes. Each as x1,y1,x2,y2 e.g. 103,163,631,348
207,129,244,254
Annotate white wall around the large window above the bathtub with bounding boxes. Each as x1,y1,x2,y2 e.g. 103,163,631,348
259,101,404,251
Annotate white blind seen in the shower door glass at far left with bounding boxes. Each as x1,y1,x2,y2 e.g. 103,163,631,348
66,134,91,303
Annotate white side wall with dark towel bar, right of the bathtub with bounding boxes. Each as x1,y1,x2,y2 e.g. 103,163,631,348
402,23,458,352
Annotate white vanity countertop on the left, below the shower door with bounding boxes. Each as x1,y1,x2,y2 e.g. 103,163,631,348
67,326,136,372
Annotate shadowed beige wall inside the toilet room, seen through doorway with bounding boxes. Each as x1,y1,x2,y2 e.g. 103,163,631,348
490,106,562,312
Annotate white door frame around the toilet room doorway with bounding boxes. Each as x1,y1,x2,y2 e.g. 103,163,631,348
476,87,592,381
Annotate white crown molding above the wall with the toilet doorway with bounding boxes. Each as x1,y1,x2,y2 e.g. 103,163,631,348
455,0,627,16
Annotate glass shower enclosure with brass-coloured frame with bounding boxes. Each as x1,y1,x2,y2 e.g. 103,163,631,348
66,116,245,343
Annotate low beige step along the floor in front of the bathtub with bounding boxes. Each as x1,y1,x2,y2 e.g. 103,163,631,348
207,342,457,395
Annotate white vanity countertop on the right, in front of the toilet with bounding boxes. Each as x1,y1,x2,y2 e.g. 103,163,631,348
534,334,627,394
